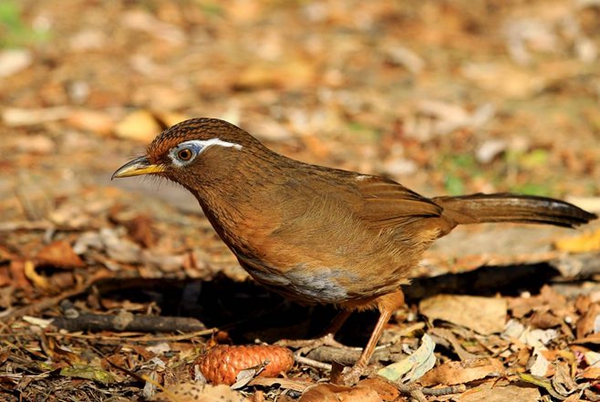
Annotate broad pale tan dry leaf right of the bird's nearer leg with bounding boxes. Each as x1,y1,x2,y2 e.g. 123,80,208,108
419,295,507,335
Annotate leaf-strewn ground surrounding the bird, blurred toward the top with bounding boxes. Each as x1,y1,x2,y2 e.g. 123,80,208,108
0,0,600,402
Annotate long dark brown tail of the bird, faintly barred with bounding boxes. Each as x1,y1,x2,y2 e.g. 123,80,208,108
433,193,598,228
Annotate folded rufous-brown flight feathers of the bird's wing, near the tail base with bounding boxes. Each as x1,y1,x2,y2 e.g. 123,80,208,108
355,176,442,229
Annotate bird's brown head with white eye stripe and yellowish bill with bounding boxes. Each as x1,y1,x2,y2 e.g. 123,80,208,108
112,118,266,190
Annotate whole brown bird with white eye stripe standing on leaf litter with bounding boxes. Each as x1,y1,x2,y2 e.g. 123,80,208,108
112,118,596,382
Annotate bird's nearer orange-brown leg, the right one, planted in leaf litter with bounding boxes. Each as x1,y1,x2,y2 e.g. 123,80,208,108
342,290,404,385
